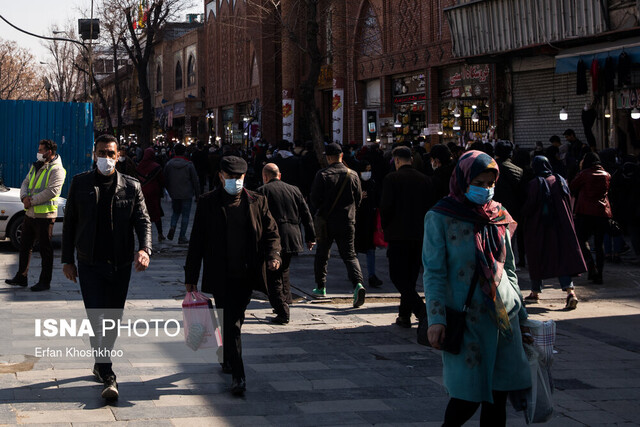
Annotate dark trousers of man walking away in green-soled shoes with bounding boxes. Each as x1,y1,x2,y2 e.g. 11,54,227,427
313,223,363,288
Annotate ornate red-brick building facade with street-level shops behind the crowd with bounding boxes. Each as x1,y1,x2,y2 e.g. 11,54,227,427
205,0,504,150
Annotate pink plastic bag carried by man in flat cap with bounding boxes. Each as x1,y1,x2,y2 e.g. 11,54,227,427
182,291,222,351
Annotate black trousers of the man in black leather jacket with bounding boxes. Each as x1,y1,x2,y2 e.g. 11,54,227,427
78,262,131,378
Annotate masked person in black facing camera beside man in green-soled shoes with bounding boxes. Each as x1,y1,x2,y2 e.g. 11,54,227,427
355,160,382,288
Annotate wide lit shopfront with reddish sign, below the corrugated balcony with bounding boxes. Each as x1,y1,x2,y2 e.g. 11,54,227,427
439,64,496,143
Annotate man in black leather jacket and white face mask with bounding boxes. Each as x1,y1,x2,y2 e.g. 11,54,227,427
62,134,151,400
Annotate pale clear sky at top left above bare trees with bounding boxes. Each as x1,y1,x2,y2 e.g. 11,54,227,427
0,0,204,62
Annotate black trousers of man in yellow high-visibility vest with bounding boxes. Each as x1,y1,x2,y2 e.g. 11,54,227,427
18,219,56,285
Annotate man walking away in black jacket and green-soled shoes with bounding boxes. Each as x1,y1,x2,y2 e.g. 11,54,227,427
310,142,365,307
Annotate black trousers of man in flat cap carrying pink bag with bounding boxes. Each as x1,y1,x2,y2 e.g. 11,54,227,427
215,278,251,378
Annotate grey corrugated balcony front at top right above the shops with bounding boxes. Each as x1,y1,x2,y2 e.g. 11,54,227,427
445,0,608,57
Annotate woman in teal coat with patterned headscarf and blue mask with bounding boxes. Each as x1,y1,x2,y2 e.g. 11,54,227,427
422,151,532,426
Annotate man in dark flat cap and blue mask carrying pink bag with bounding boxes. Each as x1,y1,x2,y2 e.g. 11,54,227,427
184,156,282,395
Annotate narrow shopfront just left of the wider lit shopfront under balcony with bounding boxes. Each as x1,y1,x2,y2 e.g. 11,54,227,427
391,73,427,142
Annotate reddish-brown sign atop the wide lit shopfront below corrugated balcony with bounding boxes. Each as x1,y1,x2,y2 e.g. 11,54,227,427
440,64,491,98
